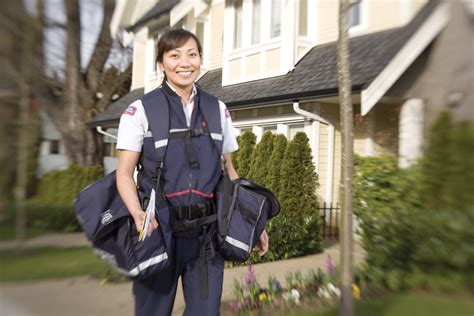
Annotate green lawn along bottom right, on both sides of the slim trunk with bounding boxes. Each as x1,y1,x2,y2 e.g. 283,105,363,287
279,292,474,316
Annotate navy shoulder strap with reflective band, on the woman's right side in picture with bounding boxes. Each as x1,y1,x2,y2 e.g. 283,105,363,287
198,88,224,155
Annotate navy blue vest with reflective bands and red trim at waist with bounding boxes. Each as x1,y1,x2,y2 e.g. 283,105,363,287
139,84,223,205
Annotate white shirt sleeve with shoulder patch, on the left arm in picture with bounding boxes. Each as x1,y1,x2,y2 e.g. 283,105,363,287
117,100,148,152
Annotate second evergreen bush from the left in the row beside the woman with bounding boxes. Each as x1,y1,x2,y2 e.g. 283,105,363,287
247,131,274,187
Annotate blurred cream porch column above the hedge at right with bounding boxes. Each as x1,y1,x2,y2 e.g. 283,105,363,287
398,99,425,168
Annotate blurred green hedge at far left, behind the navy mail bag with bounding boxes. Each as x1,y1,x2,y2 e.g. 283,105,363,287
27,165,104,231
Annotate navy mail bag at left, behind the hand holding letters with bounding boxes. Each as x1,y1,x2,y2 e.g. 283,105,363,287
74,171,171,279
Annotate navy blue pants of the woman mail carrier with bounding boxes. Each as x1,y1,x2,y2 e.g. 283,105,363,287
133,233,224,316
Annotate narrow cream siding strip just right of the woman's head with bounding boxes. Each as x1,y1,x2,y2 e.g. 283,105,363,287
209,2,224,70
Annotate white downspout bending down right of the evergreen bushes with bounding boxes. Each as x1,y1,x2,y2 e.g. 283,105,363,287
293,100,334,207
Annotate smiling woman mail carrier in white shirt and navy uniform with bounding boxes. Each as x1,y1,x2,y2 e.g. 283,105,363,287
117,29,268,315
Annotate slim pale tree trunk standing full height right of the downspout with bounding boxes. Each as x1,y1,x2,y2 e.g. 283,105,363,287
337,0,354,316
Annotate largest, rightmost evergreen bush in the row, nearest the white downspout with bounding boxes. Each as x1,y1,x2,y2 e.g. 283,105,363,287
268,132,321,259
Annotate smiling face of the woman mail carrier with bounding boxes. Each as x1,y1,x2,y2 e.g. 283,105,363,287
158,37,201,90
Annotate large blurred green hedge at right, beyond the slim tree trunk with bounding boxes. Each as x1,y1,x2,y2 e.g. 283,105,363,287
353,113,474,289
